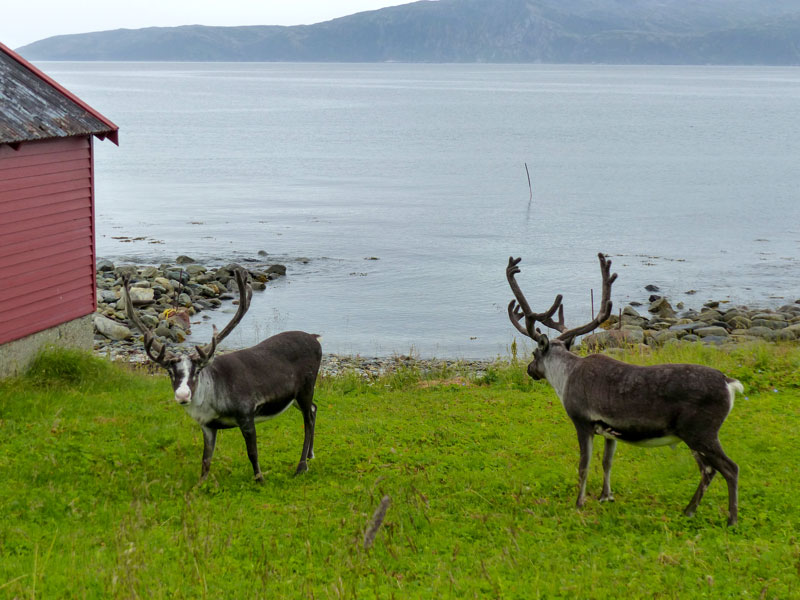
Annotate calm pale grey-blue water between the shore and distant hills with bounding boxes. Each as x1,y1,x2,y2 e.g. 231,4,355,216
40,63,800,357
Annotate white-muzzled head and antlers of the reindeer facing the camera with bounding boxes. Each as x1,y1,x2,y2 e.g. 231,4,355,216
122,268,253,405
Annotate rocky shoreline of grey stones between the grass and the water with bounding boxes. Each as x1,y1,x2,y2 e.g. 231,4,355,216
95,256,800,378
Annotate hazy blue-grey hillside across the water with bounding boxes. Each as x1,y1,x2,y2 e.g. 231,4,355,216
18,0,800,65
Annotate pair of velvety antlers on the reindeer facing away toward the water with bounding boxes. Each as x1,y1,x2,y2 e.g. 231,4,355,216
506,252,617,347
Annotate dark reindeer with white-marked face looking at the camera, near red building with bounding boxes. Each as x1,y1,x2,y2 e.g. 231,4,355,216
123,268,322,482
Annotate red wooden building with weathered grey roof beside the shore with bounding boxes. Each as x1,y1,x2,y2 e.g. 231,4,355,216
0,44,118,376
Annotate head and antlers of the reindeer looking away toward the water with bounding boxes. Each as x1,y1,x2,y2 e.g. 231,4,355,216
506,253,617,379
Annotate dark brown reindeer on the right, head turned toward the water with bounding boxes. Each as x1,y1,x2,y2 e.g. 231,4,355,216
506,254,744,526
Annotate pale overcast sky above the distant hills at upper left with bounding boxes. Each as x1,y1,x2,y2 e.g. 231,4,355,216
0,0,411,48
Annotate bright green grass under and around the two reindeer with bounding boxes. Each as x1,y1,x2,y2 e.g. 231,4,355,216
0,345,800,599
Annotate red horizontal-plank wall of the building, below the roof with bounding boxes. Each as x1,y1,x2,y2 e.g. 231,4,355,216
0,136,96,344
